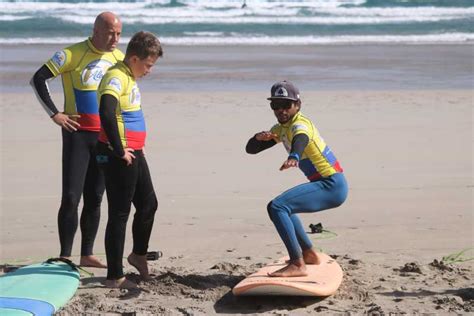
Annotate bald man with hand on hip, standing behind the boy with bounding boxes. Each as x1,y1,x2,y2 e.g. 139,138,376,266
30,12,124,268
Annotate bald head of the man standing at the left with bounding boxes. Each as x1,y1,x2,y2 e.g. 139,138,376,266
92,12,122,52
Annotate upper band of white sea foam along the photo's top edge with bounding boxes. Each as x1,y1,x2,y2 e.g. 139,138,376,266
0,1,474,24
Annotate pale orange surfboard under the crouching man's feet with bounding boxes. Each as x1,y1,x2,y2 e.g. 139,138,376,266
232,253,343,296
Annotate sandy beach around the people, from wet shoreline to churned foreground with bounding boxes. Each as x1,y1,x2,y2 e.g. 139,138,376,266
0,45,474,315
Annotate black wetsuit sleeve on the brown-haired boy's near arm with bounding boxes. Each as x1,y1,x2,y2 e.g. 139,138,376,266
99,94,125,158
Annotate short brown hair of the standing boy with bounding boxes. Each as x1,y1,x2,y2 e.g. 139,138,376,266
125,31,163,60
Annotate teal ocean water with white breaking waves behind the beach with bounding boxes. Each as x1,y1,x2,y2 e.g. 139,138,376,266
0,0,474,45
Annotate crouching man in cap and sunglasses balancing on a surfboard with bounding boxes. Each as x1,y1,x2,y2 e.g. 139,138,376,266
246,81,348,277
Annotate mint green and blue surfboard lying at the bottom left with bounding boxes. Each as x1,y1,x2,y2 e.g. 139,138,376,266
0,260,79,316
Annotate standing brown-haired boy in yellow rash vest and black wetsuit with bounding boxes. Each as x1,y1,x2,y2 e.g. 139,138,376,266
97,32,163,288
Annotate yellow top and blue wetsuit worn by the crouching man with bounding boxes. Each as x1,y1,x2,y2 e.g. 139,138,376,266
246,112,348,260
